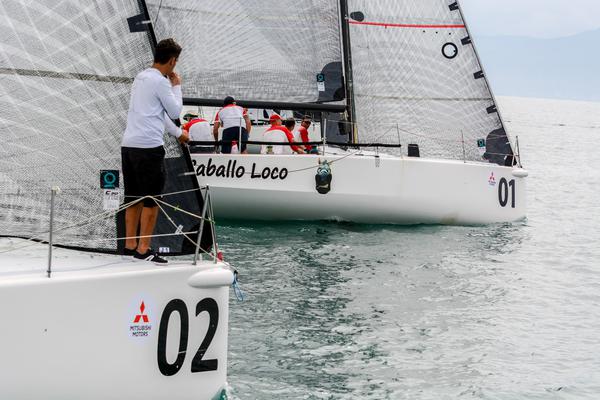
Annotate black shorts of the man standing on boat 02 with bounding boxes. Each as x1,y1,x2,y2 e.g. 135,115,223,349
121,146,165,207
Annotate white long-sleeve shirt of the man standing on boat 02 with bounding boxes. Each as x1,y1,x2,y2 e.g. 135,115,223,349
121,68,183,149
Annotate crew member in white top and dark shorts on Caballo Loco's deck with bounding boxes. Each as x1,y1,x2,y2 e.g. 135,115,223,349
213,96,252,154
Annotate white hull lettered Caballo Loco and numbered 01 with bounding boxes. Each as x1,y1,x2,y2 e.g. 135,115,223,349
192,152,527,225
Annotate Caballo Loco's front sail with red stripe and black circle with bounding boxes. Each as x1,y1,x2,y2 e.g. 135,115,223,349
348,0,513,165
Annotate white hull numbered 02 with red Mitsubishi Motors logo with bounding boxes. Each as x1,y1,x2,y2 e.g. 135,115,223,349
0,241,233,400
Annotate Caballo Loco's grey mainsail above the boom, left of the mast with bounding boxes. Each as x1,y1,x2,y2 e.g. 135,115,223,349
147,0,344,103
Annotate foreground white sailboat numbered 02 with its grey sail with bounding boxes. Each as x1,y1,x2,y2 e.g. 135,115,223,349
0,0,234,400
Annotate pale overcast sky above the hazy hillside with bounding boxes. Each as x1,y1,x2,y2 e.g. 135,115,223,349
460,0,600,38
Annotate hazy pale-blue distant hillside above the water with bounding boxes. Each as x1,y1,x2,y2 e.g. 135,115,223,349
475,30,600,101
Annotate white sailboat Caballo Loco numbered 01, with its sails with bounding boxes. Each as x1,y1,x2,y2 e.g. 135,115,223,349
148,0,528,225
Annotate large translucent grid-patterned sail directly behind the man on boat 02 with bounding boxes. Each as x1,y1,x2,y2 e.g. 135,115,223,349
0,0,204,253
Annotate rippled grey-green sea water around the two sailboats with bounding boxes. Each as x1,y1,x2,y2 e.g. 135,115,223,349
218,98,600,400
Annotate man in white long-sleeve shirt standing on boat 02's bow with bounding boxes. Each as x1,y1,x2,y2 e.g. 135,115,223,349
121,39,189,264
